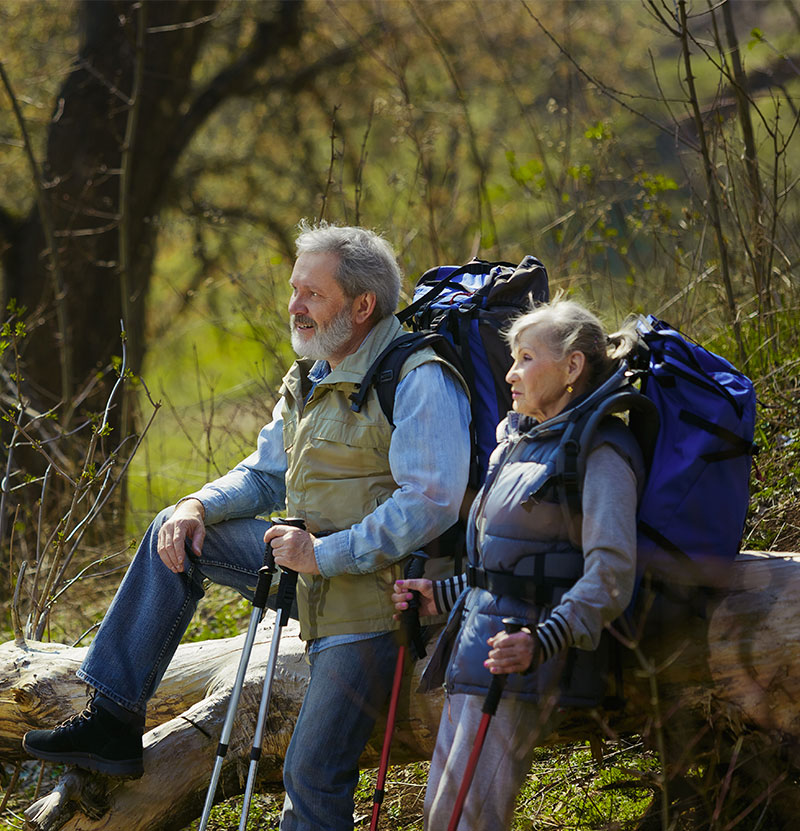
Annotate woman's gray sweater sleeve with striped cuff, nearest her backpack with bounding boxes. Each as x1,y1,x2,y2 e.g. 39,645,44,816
538,444,638,657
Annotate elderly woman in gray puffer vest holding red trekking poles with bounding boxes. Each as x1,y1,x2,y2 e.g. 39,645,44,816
392,299,645,831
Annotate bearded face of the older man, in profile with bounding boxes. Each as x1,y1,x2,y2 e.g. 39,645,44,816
289,252,353,362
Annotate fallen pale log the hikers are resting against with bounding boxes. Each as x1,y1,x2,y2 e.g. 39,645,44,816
0,552,800,831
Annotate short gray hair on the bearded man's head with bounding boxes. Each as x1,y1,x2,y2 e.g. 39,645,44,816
296,220,402,320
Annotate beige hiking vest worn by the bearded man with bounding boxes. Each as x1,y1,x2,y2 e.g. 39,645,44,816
281,316,460,640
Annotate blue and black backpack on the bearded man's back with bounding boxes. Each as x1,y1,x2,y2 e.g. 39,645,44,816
351,255,549,490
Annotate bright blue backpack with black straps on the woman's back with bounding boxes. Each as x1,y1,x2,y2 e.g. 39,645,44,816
556,315,756,586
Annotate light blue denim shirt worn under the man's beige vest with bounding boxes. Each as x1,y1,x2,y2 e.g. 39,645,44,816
191,361,470,648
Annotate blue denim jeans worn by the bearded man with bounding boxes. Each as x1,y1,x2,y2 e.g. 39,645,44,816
78,508,397,831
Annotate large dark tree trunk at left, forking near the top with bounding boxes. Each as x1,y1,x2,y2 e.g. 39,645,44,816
0,0,303,612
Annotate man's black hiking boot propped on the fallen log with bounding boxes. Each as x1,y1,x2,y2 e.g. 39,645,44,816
22,699,144,779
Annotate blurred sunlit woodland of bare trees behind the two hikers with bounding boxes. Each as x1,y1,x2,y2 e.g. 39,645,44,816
0,0,800,640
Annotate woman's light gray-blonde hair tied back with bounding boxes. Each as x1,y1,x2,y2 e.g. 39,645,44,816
505,295,638,389
